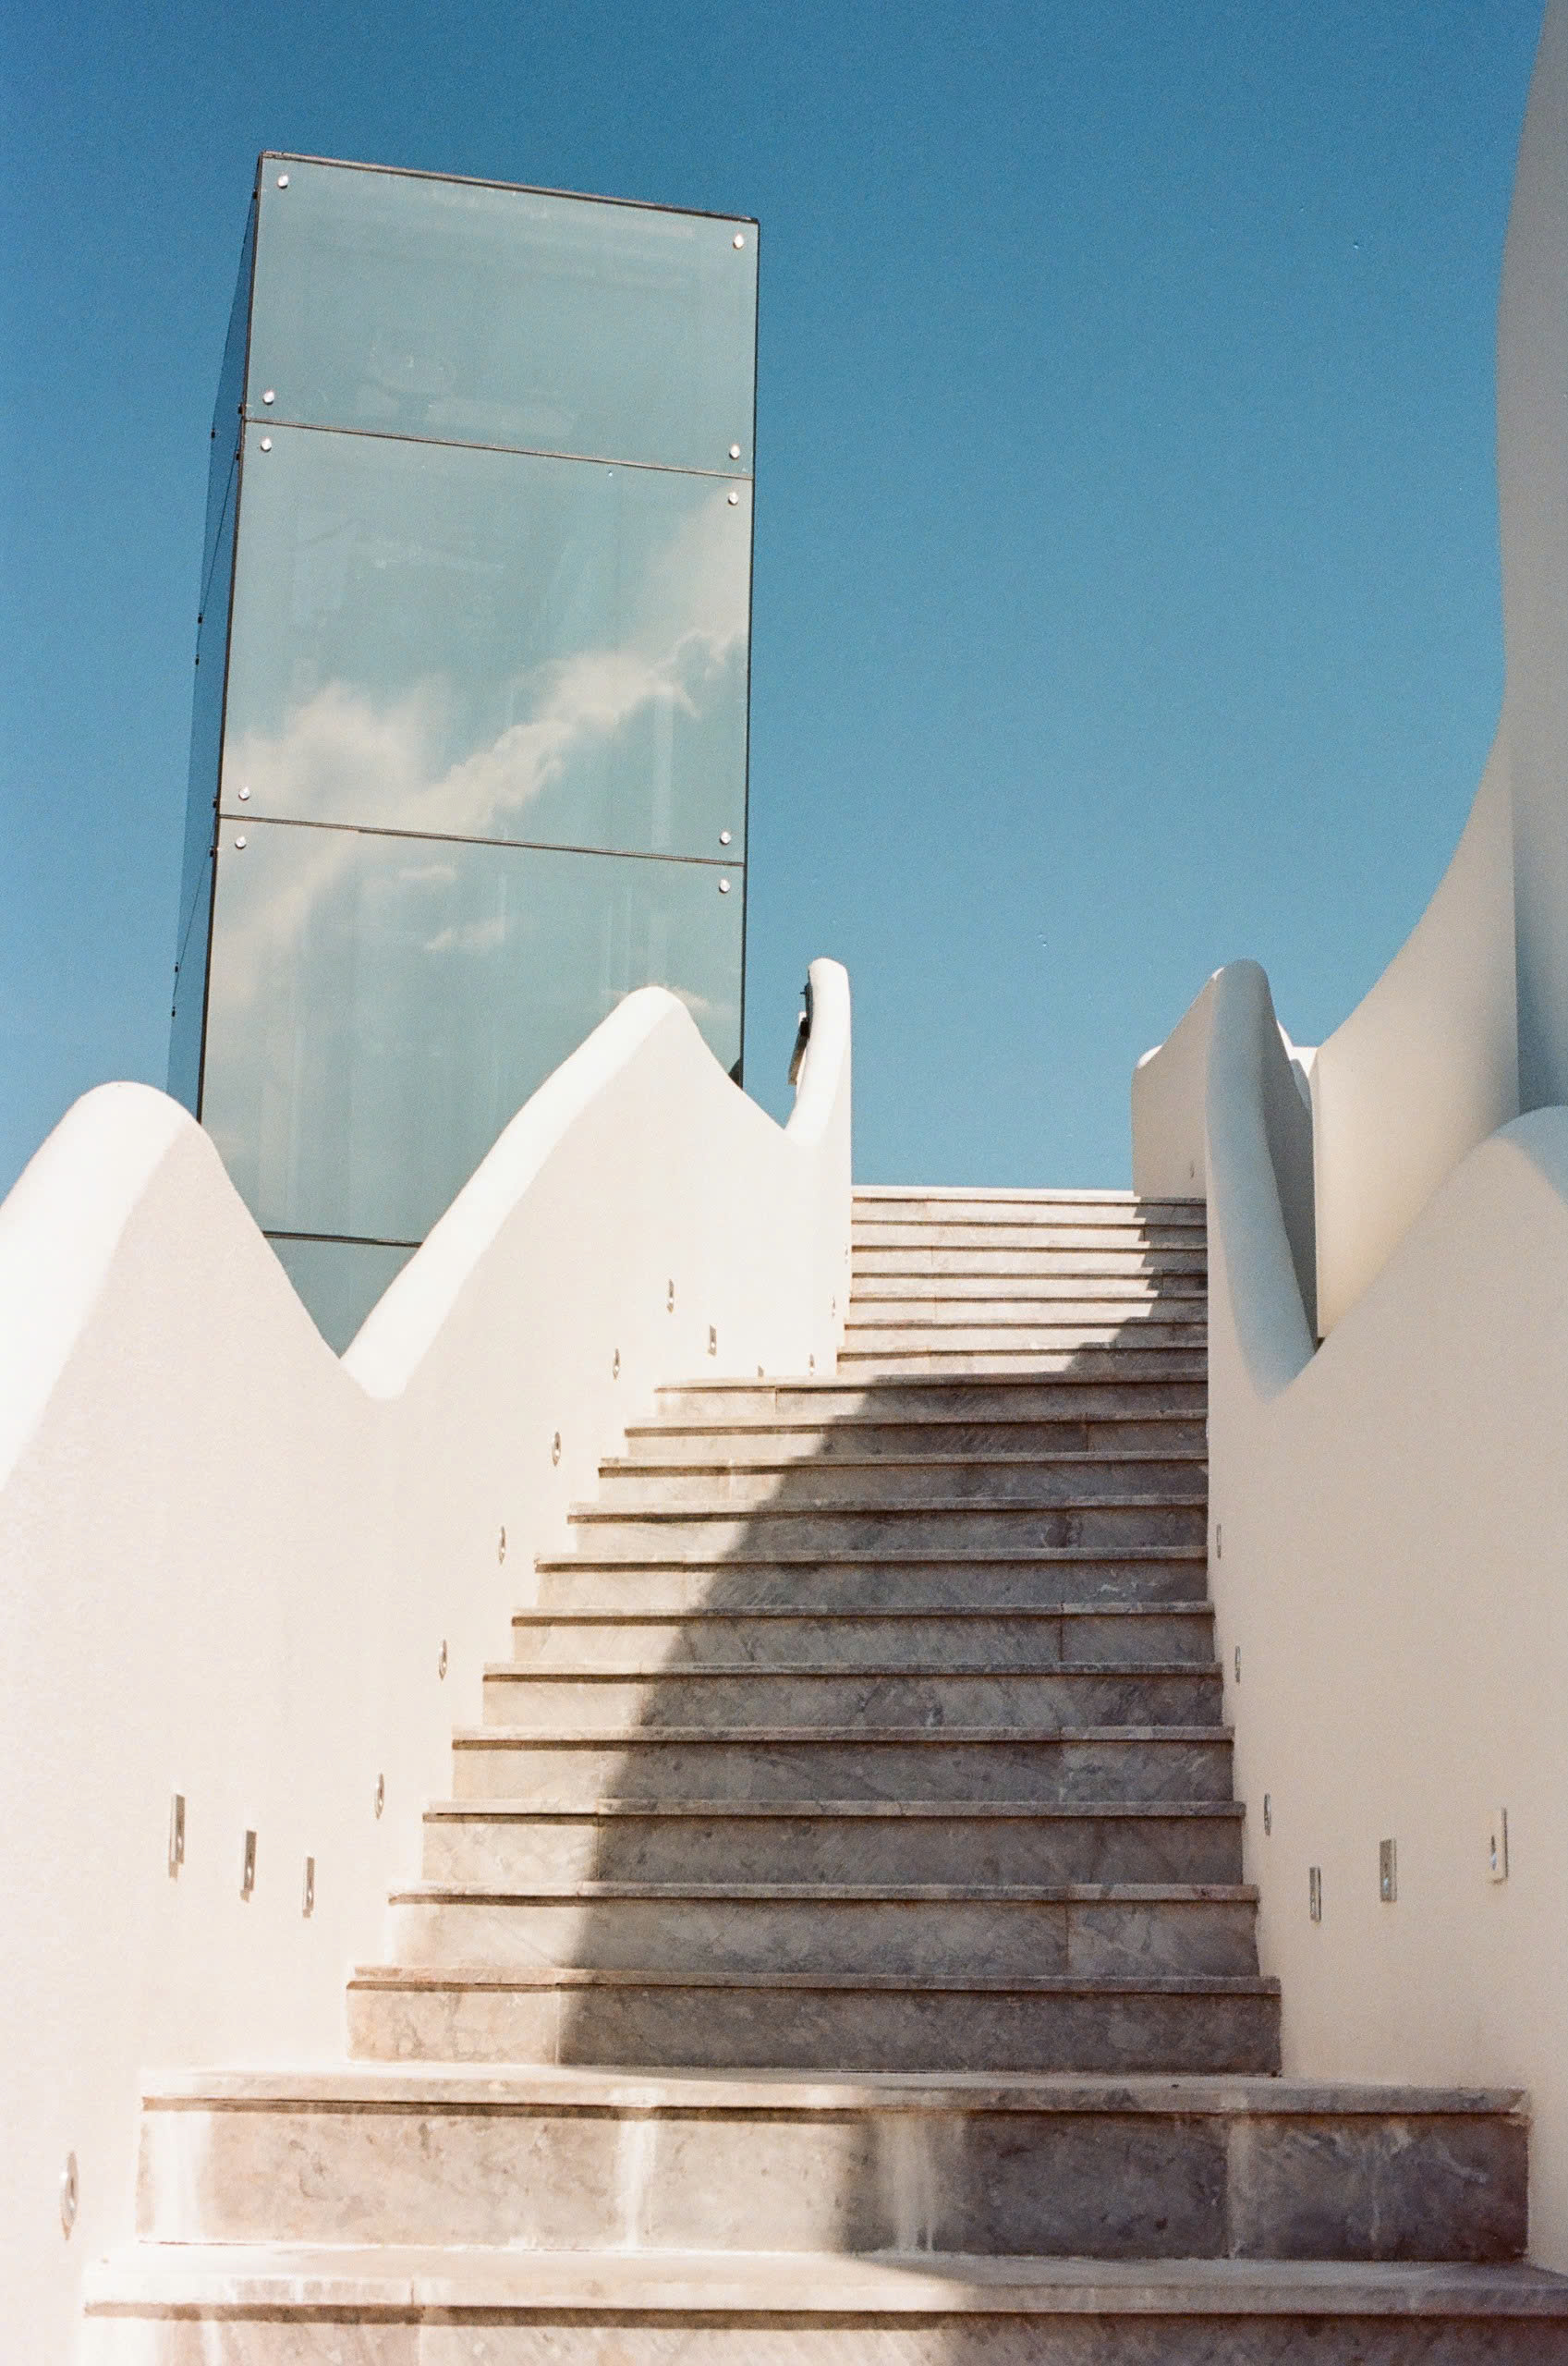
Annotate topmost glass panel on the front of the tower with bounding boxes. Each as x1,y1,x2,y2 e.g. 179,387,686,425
246,156,757,470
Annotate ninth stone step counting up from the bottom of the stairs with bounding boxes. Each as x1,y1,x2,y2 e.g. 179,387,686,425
537,1545,1209,1616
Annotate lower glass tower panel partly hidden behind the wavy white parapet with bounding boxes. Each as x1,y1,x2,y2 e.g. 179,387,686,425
201,819,743,1242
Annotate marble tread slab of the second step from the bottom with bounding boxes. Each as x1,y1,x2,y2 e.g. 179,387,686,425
142,2061,1527,2120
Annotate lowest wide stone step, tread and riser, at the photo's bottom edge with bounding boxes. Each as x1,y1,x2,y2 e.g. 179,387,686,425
83,2240,1568,2366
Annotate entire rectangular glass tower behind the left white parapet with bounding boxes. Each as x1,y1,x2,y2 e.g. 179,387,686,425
170,156,757,1348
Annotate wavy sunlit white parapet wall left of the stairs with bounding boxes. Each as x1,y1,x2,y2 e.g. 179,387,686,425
0,960,851,2359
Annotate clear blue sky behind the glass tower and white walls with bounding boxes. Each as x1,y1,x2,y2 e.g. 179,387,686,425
0,0,1542,1190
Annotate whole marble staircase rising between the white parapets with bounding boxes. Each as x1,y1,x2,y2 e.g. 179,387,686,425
88,1192,1568,2366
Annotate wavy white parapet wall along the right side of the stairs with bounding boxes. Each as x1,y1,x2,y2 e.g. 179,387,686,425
1154,963,1568,2269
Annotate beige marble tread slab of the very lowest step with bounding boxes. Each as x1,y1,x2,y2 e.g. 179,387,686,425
85,2243,1568,2321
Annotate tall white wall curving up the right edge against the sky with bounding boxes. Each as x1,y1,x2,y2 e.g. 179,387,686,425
1313,0,1568,1332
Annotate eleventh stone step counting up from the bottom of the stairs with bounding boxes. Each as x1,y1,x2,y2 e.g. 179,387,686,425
593,1448,1209,1512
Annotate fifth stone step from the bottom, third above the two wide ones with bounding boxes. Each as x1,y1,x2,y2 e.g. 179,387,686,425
423,1799,1244,1885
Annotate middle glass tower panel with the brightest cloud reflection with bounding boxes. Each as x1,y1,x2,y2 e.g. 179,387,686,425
223,423,752,859
